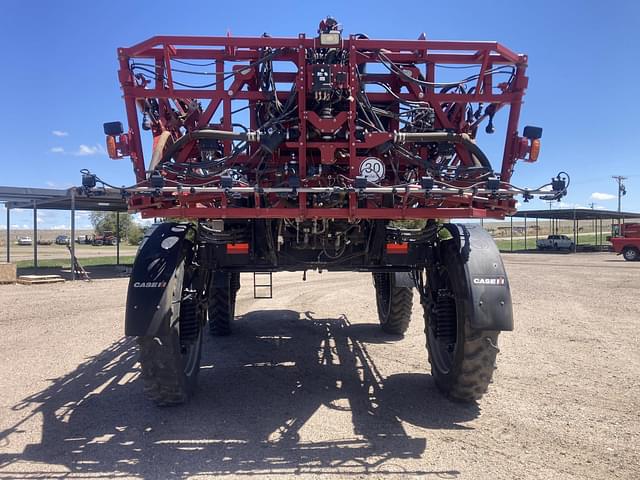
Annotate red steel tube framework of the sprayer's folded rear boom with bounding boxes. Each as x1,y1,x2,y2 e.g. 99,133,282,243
118,34,528,219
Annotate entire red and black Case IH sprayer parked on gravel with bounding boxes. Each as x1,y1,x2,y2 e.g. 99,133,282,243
83,18,566,405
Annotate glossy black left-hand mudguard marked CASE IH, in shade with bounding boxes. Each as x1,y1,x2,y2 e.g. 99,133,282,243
124,223,192,337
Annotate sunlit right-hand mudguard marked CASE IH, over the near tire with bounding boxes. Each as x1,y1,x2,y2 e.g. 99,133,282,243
445,224,513,331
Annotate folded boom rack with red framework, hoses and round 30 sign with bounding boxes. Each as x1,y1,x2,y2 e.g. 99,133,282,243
111,32,540,220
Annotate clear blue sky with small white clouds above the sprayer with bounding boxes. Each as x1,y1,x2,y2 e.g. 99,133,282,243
0,0,640,227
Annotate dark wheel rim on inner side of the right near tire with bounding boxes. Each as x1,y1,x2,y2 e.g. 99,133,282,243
427,269,458,375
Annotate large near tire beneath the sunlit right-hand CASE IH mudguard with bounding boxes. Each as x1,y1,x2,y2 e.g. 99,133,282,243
422,225,512,402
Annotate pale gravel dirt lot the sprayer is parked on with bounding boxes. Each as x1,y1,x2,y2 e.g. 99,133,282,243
0,254,640,479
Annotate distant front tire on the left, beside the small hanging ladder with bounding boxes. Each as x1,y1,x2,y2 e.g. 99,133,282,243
209,272,240,336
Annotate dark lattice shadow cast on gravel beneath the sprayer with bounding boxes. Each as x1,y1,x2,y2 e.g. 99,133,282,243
0,310,479,478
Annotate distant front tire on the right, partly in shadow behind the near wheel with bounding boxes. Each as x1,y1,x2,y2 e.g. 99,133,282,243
373,273,413,335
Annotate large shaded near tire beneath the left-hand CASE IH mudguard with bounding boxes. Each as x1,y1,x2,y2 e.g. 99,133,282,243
137,260,204,406
